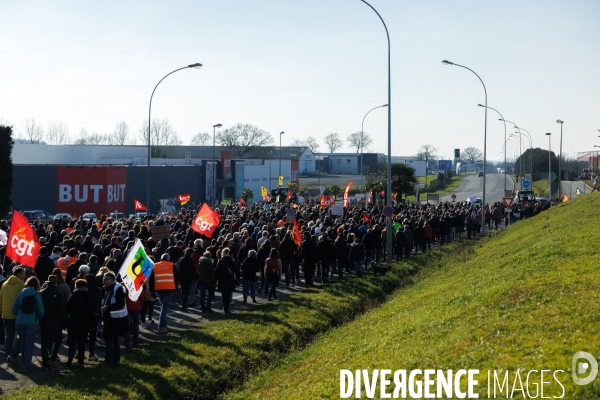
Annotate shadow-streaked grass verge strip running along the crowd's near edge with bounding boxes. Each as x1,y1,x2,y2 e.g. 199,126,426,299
6,253,418,399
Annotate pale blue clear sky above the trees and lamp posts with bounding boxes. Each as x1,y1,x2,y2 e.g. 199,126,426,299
0,0,600,160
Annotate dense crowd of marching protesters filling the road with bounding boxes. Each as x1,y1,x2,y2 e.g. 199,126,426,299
0,197,549,372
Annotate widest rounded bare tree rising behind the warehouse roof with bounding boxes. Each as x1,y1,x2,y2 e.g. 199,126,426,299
217,124,273,158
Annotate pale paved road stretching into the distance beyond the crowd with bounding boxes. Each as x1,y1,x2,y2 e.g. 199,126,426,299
440,174,513,204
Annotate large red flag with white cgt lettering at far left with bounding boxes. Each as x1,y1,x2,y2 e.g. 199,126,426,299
6,210,40,268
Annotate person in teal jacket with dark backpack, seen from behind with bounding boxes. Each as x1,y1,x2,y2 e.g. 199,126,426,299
7,276,44,373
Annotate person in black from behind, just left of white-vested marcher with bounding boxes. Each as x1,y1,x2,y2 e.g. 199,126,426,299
65,279,96,368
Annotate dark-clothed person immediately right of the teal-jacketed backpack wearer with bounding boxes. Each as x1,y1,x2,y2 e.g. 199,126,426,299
40,275,65,368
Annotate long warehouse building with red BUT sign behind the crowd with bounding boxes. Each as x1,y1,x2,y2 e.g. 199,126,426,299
12,144,315,215
